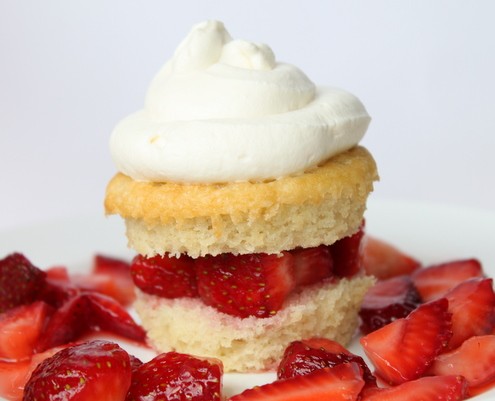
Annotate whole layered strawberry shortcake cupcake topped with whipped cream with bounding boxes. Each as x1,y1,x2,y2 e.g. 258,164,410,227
105,21,377,372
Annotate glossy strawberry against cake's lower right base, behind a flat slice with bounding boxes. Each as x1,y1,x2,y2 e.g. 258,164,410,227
277,339,376,387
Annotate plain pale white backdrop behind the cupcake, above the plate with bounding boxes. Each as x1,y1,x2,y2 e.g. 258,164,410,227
0,0,495,230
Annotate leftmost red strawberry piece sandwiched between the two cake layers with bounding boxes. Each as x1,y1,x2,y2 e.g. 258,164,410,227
131,255,198,298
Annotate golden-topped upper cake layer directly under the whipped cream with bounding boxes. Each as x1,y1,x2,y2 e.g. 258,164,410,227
105,146,378,257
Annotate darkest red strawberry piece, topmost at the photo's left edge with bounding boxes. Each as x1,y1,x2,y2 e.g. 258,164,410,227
0,253,46,313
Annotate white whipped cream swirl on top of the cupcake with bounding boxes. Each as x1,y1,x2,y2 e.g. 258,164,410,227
110,21,370,183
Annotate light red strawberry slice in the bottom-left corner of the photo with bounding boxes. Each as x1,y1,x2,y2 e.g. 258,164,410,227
0,347,65,401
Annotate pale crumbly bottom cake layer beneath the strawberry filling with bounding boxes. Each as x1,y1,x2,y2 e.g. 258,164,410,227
135,276,374,372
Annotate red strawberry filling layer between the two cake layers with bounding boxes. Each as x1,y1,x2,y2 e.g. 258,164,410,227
131,220,364,318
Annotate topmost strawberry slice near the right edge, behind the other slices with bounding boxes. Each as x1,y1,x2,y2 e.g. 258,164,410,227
412,259,484,302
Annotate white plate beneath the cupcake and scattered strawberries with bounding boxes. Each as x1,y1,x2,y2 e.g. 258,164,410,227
0,200,495,401
